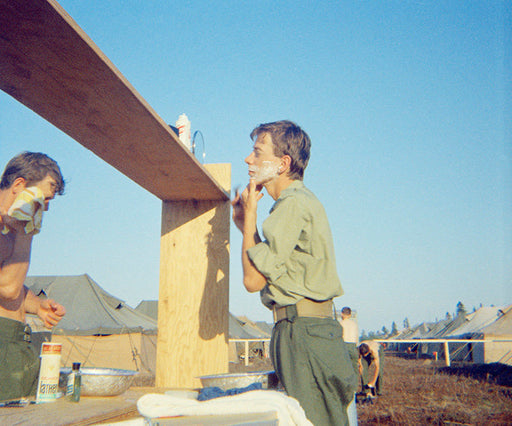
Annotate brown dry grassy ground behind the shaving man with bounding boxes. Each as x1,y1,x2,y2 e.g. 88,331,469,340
230,353,512,426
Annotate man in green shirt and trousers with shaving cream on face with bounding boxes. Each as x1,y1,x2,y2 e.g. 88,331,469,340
232,121,357,426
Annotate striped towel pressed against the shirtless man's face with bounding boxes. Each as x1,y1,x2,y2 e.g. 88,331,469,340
2,186,44,234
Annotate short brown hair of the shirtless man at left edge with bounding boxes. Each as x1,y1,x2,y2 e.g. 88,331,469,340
0,151,65,195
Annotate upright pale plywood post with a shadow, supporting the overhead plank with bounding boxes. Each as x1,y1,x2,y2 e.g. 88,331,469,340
155,164,231,388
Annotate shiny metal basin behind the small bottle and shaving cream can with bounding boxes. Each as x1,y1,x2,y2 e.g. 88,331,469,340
59,367,138,396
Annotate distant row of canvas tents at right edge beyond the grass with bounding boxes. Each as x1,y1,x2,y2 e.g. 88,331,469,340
387,305,512,365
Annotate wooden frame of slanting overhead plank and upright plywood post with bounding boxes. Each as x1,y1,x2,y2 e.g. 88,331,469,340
0,0,231,387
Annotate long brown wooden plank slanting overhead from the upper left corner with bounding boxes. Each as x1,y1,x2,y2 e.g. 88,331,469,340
0,0,229,201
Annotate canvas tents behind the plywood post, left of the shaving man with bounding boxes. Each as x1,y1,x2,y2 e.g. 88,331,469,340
25,274,271,374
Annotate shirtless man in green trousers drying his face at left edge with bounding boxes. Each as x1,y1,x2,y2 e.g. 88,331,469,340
0,152,66,400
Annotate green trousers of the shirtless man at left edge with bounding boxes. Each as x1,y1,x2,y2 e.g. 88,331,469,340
0,317,40,401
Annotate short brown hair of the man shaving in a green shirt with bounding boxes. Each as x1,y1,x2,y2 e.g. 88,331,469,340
251,120,311,180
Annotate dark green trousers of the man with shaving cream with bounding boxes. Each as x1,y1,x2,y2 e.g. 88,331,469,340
270,317,357,426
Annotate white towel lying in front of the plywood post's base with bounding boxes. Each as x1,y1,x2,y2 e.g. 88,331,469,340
137,390,313,426
